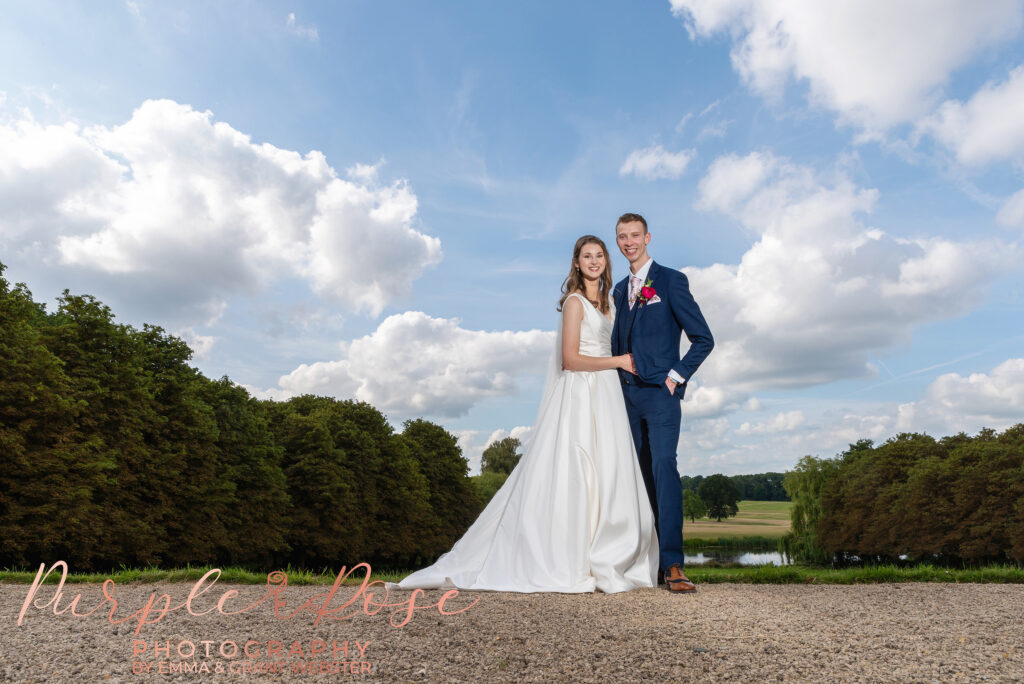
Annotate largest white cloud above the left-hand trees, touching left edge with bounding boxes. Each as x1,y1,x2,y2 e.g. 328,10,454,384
0,100,441,327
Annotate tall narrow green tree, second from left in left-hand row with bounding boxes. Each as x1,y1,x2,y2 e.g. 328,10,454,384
40,290,169,569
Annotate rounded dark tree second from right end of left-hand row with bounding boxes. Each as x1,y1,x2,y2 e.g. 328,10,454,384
271,394,435,566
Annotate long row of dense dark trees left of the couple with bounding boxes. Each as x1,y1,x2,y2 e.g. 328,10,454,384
0,263,483,570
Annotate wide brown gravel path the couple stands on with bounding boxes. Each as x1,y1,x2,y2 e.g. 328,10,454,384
0,583,1024,682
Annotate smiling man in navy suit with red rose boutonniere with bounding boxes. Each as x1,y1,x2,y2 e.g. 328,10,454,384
611,214,715,592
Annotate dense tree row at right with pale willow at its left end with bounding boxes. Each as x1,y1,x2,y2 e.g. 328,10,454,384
783,424,1024,564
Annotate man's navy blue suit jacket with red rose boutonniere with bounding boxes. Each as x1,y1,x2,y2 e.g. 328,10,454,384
611,262,715,400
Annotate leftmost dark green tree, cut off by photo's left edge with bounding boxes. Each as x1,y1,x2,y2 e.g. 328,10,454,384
0,263,114,567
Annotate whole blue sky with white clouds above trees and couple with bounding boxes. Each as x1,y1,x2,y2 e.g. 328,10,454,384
0,0,1024,474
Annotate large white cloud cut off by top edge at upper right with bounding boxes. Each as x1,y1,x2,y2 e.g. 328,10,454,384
671,0,1022,131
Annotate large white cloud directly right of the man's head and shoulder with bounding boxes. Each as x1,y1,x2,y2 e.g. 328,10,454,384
685,153,1016,395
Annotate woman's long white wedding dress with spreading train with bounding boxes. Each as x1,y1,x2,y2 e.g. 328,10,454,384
387,295,658,593
